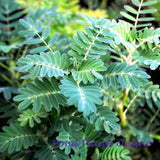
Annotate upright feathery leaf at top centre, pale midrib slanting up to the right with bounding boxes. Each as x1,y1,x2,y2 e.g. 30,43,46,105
69,14,116,59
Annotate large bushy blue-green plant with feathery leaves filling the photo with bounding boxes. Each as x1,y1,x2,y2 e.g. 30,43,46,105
0,0,160,160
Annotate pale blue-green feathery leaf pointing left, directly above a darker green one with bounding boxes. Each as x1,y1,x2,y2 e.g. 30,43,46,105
18,52,69,78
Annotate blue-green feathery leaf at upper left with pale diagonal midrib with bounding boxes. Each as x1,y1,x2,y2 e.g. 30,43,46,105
19,17,67,54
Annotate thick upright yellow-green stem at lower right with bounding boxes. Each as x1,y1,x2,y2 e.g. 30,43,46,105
119,88,129,128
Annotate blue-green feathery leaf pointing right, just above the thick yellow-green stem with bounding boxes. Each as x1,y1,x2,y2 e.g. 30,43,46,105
103,62,150,88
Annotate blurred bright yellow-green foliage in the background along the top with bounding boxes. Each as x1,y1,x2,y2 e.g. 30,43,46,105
16,0,108,37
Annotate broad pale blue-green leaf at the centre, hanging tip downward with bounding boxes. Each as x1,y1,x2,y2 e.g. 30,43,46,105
60,77,102,117
